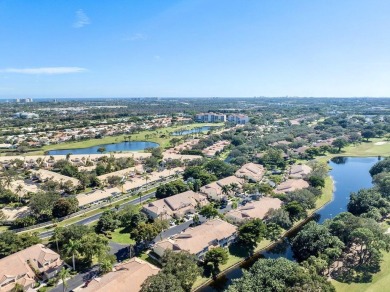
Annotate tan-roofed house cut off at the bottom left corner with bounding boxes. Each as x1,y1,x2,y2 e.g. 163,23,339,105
0,244,63,291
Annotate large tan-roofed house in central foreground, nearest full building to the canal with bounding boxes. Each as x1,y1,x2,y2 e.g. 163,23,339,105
153,219,237,260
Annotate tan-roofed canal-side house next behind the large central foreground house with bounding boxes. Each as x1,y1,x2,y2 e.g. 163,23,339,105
225,197,282,223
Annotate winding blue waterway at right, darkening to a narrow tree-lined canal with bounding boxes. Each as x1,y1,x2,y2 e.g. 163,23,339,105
198,157,378,292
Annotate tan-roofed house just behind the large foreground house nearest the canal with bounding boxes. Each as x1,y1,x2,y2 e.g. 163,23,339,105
142,191,209,219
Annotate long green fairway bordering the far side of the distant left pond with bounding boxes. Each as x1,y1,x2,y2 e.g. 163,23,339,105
35,123,223,155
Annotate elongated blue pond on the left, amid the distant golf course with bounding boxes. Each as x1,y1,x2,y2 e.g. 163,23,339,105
48,141,159,155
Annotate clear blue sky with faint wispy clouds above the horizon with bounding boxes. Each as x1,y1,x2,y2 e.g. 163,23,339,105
0,0,390,98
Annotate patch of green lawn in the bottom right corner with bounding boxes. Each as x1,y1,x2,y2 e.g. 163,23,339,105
332,253,390,292
